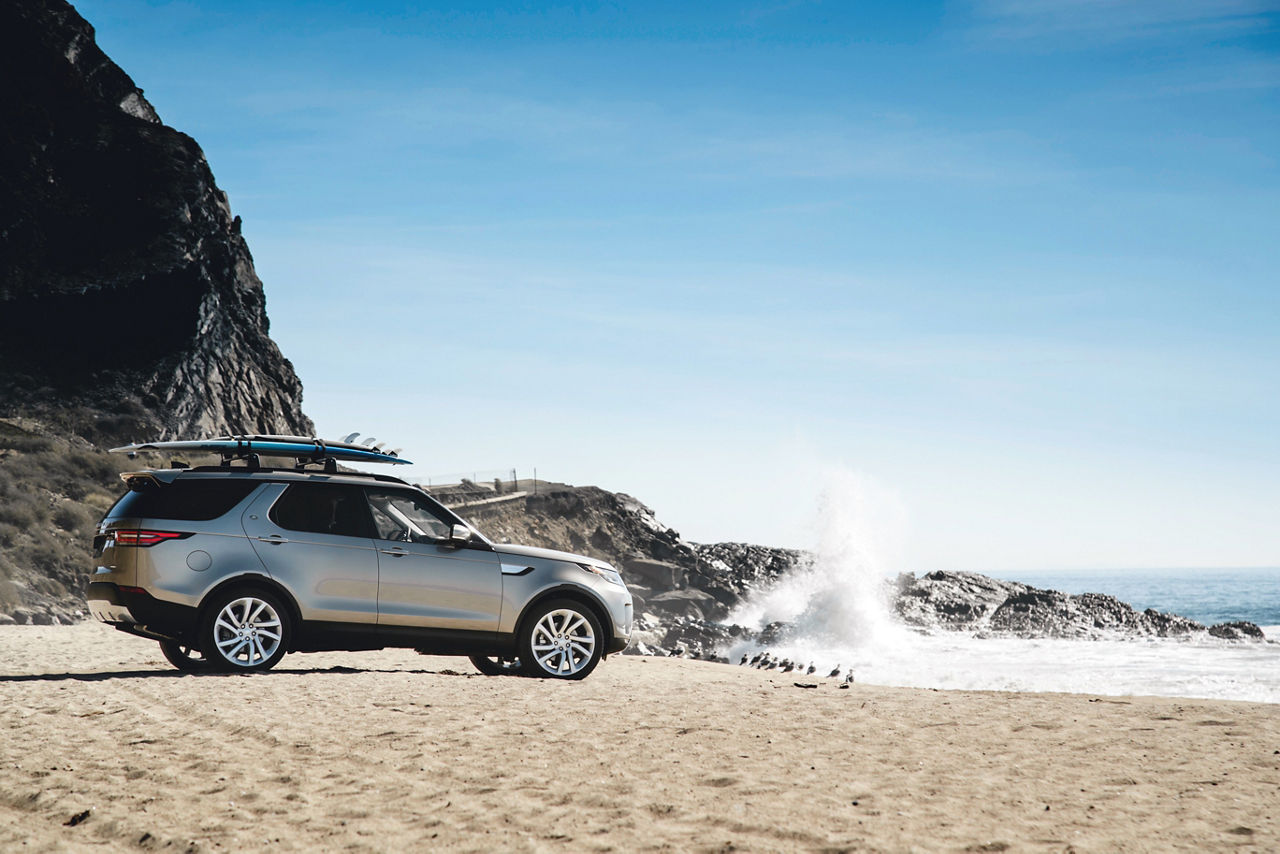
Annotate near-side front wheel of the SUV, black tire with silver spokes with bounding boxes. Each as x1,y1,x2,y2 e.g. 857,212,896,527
517,599,605,679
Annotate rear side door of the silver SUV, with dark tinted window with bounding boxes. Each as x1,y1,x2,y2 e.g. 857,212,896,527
241,481,378,625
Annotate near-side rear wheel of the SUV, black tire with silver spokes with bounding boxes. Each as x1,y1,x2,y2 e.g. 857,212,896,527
200,588,293,673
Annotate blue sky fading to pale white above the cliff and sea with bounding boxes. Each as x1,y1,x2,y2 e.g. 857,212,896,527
77,0,1280,571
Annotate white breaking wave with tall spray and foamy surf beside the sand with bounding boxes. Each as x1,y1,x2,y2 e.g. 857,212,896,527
726,471,1280,703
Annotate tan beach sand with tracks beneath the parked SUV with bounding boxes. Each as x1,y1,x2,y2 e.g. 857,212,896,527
0,624,1280,851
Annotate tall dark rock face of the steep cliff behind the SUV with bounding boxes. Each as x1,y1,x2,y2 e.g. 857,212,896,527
0,0,314,440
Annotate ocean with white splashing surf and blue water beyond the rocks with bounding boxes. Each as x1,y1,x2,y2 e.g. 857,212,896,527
723,480,1280,703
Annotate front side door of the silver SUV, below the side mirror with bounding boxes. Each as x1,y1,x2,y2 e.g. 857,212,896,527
367,488,502,631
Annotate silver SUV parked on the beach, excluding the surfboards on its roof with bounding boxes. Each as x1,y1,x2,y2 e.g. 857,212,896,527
88,460,632,679
